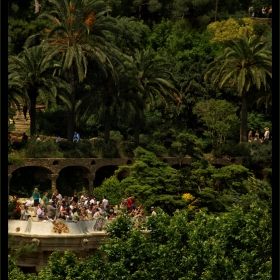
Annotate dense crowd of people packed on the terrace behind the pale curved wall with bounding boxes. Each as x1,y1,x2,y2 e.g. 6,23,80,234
8,188,156,223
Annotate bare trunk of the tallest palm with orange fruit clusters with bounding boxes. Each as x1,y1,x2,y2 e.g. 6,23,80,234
67,66,76,141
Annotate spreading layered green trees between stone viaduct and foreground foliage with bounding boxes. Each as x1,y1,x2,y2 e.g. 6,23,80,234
94,146,270,215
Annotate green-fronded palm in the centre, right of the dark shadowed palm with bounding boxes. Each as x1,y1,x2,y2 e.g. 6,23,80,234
132,50,178,146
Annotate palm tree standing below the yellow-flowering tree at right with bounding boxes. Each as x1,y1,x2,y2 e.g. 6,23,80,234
204,37,272,142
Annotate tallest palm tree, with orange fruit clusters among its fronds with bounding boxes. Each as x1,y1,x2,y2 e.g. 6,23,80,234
27,0,121,141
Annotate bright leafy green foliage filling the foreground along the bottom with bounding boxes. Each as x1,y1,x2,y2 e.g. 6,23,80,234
9,200,272,280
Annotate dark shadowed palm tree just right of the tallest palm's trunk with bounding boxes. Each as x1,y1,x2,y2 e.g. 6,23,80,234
77,56,141,141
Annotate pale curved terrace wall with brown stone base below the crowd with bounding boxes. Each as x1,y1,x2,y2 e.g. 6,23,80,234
8,219,107,272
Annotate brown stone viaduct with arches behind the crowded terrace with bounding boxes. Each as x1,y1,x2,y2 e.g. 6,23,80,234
8,157,242,195
